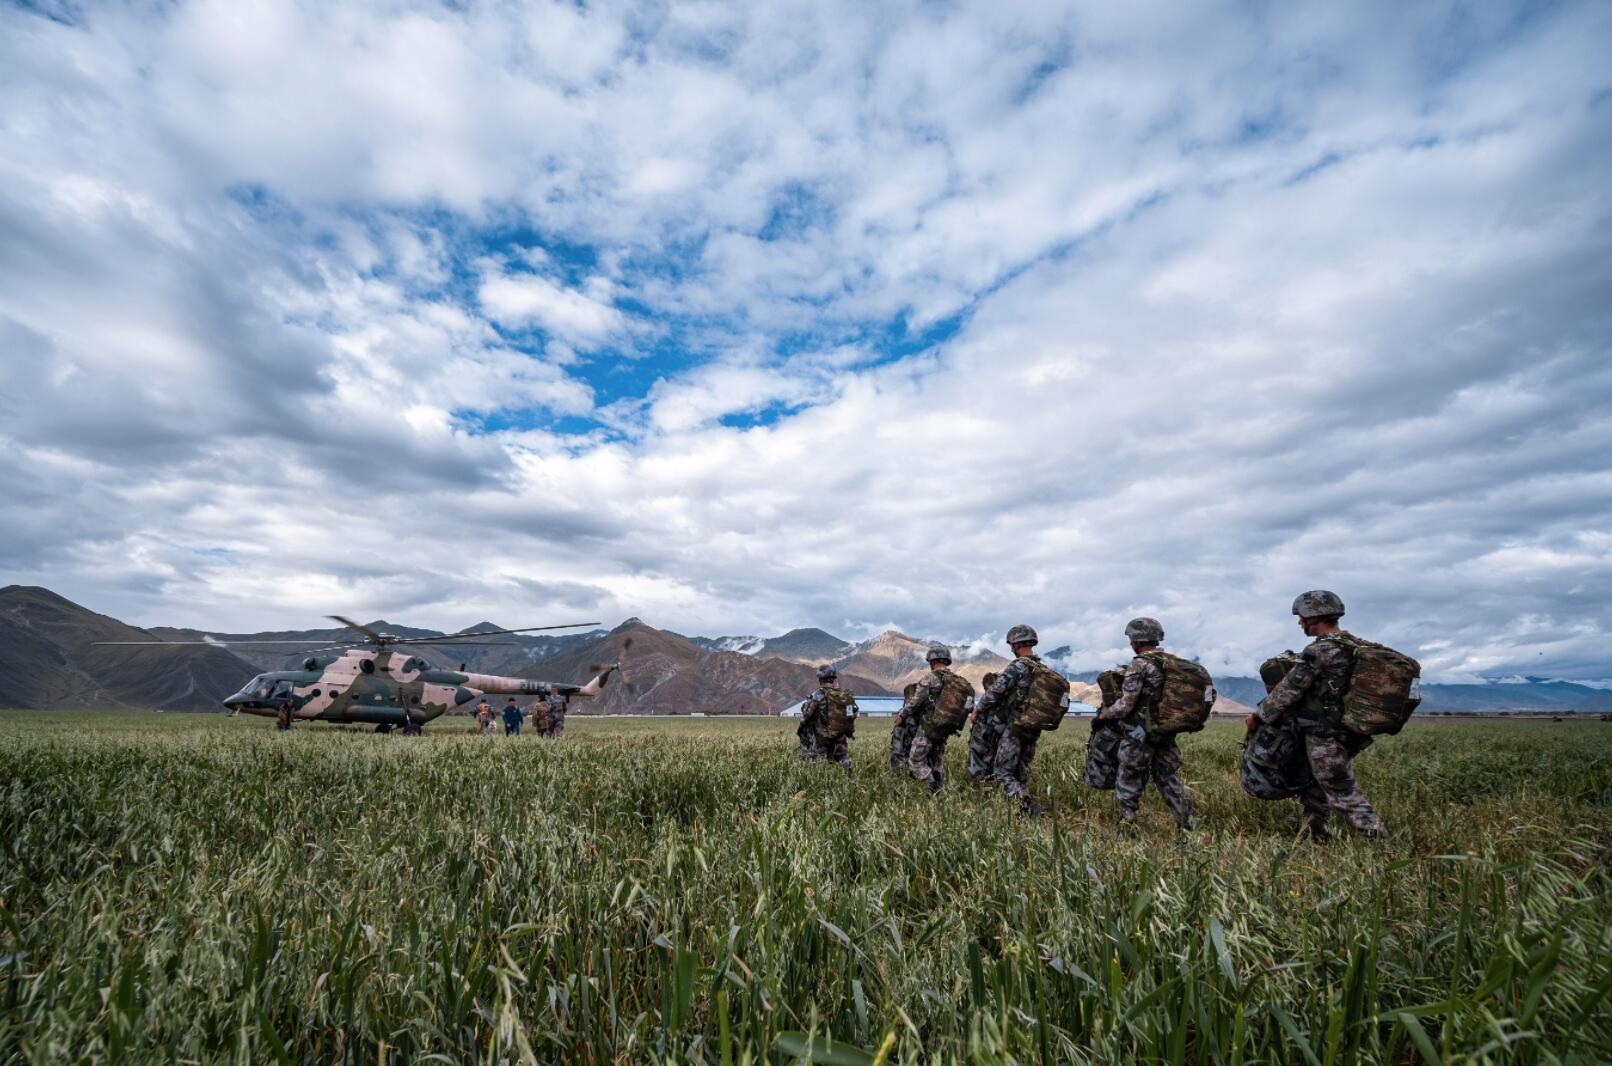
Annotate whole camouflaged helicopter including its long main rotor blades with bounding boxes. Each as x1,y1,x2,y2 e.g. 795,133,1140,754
97,614,621,735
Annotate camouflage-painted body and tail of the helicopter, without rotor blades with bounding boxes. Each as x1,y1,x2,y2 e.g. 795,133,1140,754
224,648,616,727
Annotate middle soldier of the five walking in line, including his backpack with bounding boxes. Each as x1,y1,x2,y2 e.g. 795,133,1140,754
969,626,1069,816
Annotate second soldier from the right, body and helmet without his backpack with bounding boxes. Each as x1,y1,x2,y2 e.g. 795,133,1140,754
1098,618,1193,834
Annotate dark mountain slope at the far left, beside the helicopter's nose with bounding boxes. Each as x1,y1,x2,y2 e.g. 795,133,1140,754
0,585,258,711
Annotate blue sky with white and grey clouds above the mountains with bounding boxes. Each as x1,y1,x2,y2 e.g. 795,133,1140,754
0,0,1612,681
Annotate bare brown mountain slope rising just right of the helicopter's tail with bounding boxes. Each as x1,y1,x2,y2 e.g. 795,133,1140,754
540,621,888,714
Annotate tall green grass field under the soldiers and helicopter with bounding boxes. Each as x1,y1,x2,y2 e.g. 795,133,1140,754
0,711,1612,1064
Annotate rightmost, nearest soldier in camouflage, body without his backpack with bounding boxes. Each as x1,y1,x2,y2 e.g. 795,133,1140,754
1257,589,1385,840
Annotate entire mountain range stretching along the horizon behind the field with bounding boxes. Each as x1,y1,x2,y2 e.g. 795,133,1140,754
0,585,1612,714
